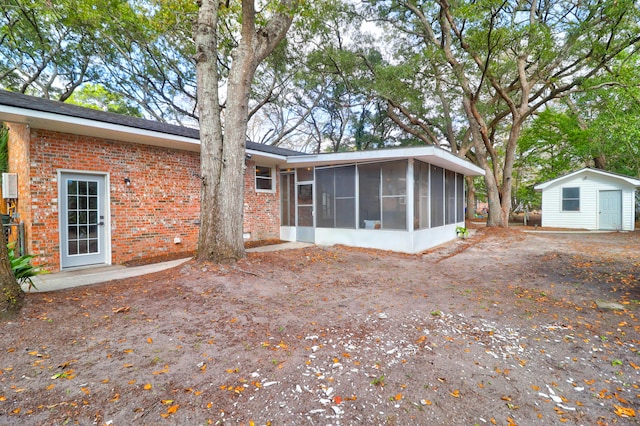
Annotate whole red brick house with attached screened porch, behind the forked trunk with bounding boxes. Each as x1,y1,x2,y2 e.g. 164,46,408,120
0,91,482,271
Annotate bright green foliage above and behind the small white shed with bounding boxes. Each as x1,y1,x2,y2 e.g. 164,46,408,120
518,54,640,182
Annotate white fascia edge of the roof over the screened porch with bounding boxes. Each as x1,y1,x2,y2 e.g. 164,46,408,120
287,146,484,176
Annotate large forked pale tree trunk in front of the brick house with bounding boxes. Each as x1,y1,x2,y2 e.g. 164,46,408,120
195,0,297,262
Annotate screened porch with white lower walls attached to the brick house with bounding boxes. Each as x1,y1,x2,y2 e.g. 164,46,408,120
280,146,481,253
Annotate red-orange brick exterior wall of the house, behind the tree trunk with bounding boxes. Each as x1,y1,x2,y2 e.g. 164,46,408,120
9,124,279,272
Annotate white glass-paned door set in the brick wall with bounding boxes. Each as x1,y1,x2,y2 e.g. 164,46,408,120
60,173,107,268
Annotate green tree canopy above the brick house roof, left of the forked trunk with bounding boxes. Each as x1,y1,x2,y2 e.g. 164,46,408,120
0,0,197,122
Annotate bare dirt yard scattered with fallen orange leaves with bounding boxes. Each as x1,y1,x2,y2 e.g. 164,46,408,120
0,229,640,425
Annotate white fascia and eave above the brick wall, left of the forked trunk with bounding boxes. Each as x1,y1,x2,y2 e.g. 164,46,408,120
0,105,200,152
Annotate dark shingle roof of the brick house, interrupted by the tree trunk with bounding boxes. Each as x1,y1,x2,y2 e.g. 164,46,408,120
0,90,304,157
